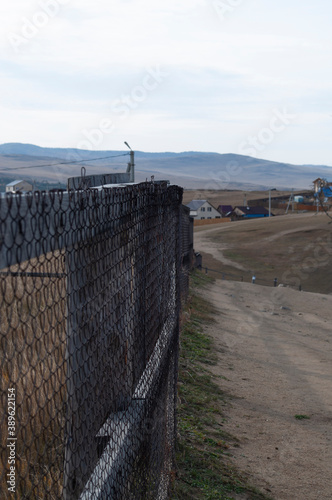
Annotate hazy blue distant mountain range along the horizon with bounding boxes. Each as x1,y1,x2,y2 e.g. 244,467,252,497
0,143,332,190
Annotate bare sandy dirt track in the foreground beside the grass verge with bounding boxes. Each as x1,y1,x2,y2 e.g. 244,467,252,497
197,272,332,500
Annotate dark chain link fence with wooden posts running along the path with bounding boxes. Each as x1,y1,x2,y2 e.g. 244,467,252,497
0,182,186,500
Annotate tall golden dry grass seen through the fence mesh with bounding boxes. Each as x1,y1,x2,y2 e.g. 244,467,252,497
0,252,66,498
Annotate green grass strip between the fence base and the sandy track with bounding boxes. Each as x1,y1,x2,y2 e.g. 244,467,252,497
171,273,270,500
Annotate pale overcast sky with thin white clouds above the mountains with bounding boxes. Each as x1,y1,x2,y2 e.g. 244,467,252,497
0,0,332,165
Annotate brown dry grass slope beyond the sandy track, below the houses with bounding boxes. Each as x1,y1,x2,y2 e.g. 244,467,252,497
195,214,332,293
